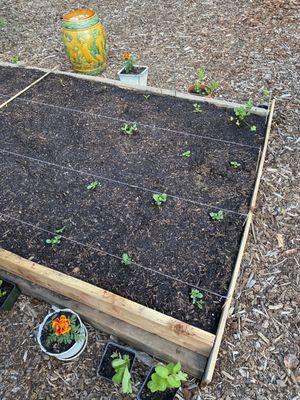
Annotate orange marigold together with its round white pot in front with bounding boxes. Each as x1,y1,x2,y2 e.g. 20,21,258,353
37,308,88,361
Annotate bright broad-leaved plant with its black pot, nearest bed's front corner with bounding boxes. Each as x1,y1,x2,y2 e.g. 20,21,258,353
137,362,188,400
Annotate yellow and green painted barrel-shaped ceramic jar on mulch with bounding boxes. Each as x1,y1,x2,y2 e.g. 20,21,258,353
62,9,108,75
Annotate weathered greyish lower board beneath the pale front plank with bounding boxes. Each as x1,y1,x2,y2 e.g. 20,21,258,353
0,270,207,379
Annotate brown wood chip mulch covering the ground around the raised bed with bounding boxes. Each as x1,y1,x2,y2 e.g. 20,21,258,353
0,0,300,400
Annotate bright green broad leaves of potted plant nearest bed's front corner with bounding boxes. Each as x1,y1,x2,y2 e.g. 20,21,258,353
147,362,188,393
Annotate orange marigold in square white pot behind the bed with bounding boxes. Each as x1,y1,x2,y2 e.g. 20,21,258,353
118,53,148,86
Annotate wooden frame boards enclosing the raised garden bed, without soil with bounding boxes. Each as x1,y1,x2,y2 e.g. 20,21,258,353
0,62,275,385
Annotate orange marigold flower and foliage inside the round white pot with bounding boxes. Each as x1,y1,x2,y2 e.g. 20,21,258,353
46,314,85,346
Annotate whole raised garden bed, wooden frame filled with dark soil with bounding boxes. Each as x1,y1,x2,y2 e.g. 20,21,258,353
0,65,274,383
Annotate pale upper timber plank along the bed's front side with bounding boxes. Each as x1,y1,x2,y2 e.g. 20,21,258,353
0,249,215,356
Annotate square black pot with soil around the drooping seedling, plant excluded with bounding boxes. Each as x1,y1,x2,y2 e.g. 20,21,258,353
97,342,136,382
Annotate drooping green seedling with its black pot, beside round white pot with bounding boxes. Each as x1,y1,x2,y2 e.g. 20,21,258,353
97,342,136,394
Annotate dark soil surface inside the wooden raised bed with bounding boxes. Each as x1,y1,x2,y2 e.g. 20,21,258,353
0,67,265,333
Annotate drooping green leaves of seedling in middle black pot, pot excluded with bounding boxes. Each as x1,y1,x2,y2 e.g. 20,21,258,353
111,352,132,394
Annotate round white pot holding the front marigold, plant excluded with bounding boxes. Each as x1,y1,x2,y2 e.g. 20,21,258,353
36,308,88,361
